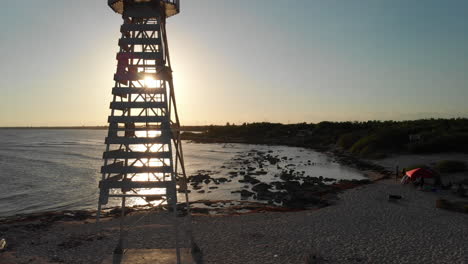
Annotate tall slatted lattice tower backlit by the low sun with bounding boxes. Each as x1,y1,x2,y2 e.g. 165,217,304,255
98,0,198,263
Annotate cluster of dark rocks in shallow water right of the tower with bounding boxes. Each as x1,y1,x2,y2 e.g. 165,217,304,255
188,150,371,209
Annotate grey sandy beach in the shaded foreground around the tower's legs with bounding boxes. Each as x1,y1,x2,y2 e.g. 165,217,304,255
0,177,468,264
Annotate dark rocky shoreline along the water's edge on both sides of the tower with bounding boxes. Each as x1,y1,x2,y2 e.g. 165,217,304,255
0,146,391,225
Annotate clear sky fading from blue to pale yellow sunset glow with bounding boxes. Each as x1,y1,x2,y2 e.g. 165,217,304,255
0,0,468,126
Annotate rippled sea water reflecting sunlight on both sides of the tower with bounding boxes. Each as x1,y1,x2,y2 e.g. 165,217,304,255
0,129,364,217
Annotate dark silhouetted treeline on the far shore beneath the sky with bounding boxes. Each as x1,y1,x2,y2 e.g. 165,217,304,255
183,118,468,157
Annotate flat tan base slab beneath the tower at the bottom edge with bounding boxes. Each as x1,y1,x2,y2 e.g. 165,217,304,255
102,248,196,264
